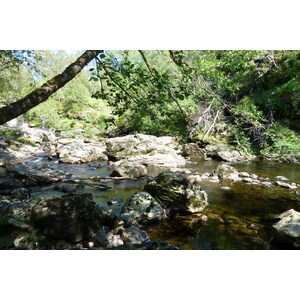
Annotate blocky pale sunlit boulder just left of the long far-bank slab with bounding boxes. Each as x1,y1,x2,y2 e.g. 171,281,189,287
56,139,108,164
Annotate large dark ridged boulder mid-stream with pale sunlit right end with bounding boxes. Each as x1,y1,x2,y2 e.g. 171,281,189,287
144,172,208,213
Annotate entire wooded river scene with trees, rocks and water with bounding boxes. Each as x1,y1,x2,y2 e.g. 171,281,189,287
0,50,300,249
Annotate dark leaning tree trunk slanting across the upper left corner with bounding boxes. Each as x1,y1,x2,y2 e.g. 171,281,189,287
0,50,103,125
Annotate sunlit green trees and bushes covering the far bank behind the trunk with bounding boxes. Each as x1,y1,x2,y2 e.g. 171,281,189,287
0,50,300,159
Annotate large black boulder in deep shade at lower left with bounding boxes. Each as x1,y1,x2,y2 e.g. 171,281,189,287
31,194,104,243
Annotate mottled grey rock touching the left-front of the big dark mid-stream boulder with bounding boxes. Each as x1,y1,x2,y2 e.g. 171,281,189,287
120,192,166,225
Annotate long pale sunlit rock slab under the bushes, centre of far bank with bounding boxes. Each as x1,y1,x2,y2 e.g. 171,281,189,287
106,134,178,160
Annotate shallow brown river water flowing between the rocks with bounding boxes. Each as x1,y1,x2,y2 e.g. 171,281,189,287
24,160,300,250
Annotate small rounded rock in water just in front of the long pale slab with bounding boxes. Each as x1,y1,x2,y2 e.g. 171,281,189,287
110,162,148,178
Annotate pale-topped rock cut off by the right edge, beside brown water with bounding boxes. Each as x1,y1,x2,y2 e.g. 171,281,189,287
272,209,300,248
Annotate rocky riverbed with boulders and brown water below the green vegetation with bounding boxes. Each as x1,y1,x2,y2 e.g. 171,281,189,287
0,130,300,249
